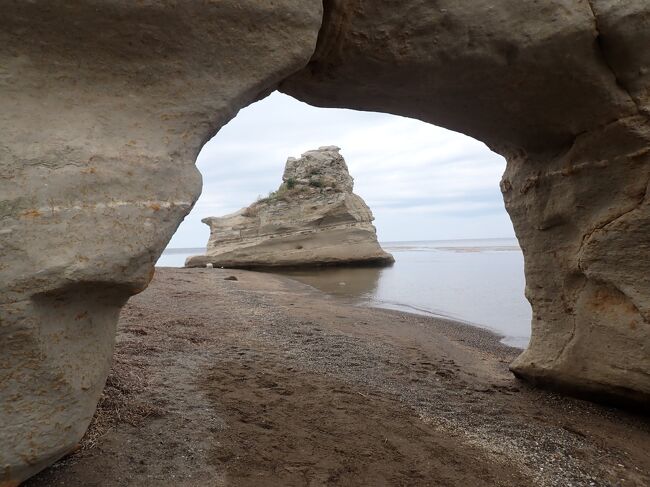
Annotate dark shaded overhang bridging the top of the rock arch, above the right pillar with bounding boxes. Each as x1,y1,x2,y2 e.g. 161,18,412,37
281,0,632,155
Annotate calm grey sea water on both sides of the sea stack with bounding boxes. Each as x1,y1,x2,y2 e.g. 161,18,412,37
157,239,531,348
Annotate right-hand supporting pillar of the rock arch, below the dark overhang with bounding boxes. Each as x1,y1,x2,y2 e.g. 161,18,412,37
501,116,650,405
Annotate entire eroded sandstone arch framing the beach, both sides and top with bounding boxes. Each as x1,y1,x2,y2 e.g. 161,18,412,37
0,0,650,485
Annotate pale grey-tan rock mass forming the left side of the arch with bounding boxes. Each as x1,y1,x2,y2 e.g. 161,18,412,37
0,0,322,486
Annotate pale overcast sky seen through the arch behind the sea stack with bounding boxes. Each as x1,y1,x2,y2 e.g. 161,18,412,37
163,92,514,248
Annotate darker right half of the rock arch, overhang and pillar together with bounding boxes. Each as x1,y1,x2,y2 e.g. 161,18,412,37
282,0,650,403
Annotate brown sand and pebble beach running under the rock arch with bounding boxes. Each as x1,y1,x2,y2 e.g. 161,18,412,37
25,268,650,487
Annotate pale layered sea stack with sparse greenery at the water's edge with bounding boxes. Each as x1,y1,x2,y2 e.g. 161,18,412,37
185,146,394,268
